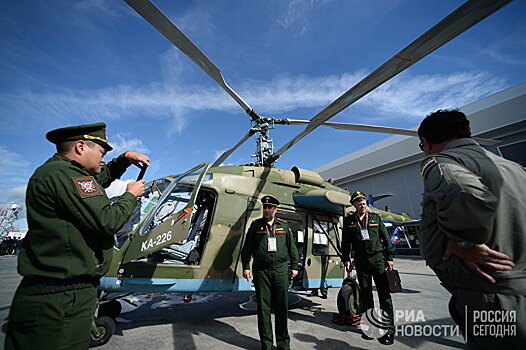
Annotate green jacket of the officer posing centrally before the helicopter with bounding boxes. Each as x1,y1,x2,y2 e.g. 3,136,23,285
241,218,299,270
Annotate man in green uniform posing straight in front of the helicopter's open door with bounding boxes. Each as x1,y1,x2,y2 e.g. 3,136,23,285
241,196,299,350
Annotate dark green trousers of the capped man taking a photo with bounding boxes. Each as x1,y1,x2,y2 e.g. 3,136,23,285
5,282,97,350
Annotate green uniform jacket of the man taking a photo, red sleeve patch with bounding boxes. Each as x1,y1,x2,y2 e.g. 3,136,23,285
18,154,137,280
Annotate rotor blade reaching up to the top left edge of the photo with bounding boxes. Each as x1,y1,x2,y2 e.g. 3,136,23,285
124,0,259,120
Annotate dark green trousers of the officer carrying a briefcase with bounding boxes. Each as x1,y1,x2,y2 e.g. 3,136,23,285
354,252,395,334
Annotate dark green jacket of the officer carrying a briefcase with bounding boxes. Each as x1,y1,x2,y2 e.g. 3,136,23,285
342,210,394,261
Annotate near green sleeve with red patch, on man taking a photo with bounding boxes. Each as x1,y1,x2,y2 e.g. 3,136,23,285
50,169,137,236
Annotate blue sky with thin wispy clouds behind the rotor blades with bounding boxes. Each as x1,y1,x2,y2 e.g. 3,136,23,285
0,0,526,226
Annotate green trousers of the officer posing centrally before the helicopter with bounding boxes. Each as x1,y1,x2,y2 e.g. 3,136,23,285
253,263,290,350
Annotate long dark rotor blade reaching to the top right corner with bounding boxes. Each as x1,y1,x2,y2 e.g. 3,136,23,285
268,0,511,164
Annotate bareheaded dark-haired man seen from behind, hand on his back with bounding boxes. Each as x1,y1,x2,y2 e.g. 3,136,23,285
418,110,526,349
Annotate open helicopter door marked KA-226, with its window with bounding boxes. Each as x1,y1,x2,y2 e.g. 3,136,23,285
122,162,210,264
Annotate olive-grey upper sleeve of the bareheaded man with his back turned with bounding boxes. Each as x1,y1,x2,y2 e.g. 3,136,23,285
424,157,498,244
